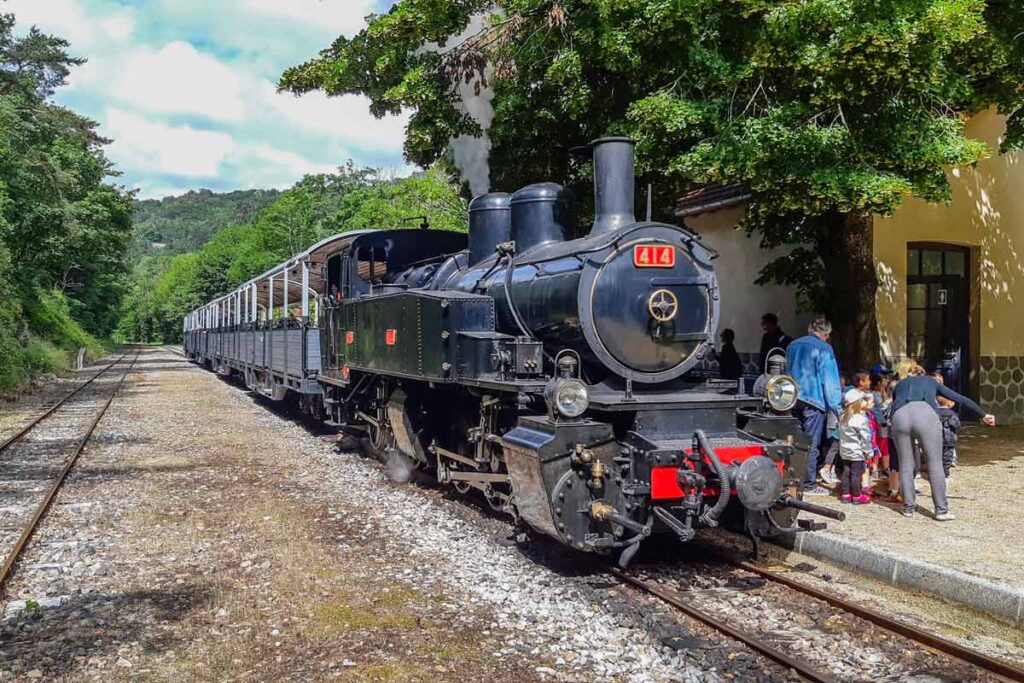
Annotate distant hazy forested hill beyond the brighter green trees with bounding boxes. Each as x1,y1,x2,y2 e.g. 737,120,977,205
132,189,281,261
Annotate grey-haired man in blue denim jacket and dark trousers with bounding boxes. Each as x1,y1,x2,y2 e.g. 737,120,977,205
785,315,843,496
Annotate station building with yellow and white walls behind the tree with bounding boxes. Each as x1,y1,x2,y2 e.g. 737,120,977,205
676,111,1024,423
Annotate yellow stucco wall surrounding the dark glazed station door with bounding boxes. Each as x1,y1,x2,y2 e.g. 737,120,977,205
873,112,1024,357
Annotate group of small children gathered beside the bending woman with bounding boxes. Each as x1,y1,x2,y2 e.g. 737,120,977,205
821,360,961,505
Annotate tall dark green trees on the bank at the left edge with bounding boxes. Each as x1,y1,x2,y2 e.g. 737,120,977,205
0,14,132,393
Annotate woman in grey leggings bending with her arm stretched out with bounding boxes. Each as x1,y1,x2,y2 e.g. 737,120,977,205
889,376,995,521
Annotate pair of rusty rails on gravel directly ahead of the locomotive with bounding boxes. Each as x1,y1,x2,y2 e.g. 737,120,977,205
609,549,1024,683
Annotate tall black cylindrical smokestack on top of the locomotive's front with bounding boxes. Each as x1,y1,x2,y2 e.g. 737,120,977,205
590,137,636,234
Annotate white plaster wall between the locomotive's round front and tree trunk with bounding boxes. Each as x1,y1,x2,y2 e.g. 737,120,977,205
685,207,811,353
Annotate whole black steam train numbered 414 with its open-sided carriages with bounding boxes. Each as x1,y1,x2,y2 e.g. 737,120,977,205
184,138,828,566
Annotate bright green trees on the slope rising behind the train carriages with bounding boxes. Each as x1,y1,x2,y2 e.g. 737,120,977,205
118,162,467,342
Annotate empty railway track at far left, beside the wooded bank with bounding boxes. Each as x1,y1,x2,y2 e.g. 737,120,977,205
0,352,139,594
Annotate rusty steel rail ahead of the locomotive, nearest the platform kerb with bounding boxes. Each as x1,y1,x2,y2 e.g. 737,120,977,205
716,551,1024,681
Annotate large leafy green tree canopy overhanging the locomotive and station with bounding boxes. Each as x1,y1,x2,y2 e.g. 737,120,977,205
281,0,1024,362
